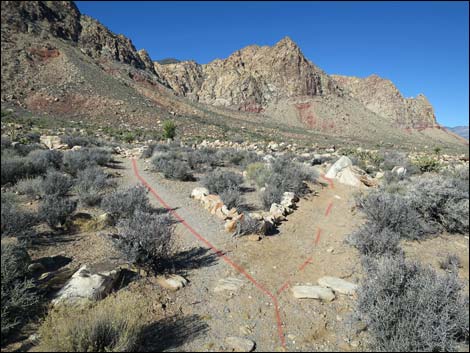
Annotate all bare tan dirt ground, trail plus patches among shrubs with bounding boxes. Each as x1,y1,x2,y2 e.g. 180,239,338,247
9,155,469,351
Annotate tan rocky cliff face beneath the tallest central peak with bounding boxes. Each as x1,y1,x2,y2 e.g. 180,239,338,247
155,37,341,112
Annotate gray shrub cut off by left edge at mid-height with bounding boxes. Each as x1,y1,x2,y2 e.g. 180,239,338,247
1,194,37,237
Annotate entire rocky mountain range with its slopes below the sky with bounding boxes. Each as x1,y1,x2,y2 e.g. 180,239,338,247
1,1,463,148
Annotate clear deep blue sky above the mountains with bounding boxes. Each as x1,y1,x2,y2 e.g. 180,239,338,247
76,1,469,126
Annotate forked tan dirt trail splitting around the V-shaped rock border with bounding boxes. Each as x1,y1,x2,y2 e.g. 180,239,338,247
117,160,360,351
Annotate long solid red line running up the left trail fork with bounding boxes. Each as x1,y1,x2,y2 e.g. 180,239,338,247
132,159,286,348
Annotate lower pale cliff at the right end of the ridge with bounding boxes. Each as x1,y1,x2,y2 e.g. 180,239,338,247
332,75,437,129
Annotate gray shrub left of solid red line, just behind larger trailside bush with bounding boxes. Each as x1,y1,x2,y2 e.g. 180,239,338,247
101,185,152,218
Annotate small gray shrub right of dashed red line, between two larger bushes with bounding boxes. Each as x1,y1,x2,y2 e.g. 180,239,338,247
348,222,402,257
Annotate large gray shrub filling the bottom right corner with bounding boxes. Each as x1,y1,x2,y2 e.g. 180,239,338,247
357,256,468,352
